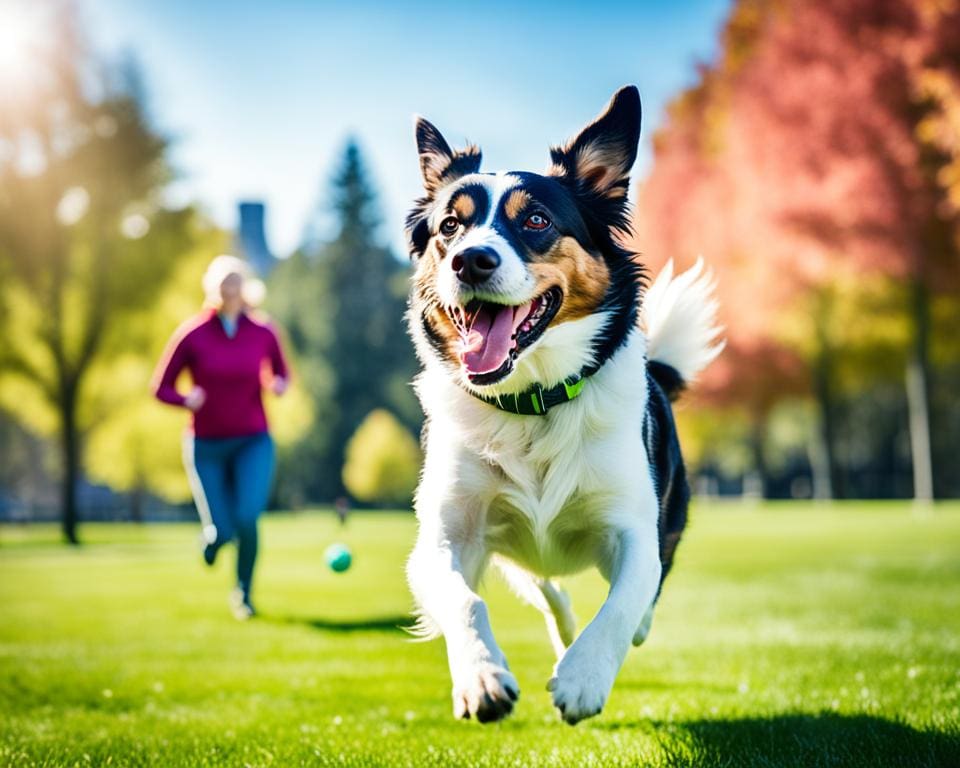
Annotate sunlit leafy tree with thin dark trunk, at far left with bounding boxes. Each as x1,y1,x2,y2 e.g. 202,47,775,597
0,10,188,543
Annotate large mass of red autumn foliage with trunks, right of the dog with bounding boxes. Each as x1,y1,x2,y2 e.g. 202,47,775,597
636,0,960,499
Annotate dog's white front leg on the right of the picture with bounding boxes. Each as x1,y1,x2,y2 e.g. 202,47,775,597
547,528,660,725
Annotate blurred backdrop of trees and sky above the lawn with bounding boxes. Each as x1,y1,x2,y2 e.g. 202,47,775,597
0,0,960,540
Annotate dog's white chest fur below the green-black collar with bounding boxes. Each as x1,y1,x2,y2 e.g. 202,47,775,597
417,332,656,576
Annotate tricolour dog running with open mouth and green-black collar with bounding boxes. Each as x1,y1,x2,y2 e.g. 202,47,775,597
406,86,722,724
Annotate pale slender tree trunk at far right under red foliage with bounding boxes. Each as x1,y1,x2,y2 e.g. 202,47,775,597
907,278,933,504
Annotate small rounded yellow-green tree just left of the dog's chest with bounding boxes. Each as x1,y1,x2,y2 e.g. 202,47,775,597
343,408,421,506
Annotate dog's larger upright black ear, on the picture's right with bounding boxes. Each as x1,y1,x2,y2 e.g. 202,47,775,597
549,85,641,199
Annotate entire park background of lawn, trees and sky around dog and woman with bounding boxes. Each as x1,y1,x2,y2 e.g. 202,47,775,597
0,0,960,768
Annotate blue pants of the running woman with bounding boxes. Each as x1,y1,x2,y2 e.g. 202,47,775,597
183,432,274,598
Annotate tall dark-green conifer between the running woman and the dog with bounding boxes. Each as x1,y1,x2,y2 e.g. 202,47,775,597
271,140,419,499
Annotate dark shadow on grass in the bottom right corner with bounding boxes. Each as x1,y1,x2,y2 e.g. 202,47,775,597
609,712,960,768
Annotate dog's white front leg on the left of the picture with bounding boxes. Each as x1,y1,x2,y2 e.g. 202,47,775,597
407,522,520,723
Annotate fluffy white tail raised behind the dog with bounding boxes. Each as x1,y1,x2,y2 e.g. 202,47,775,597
641,258,725,383
